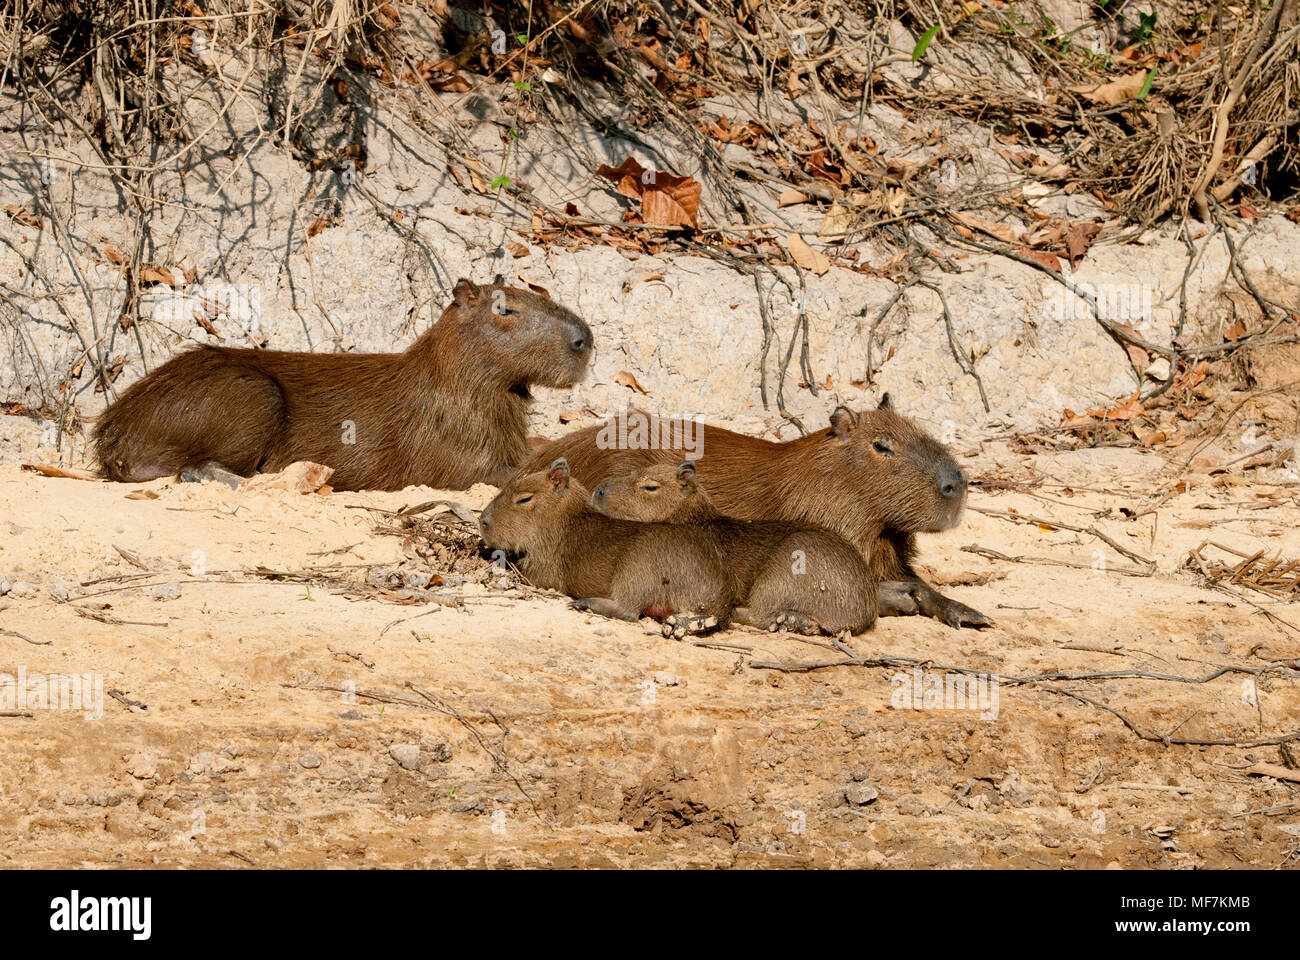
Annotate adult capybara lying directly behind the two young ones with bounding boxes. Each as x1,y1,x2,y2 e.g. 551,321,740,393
521,394,992,627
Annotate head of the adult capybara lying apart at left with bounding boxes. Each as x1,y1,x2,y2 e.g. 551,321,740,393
438,280,592,390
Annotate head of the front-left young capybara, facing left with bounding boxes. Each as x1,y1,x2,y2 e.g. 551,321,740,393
478,458,586,553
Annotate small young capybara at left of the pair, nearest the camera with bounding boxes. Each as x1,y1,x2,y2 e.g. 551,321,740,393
478,459,733,636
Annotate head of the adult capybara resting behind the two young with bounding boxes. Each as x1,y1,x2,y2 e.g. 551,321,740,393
822,394,966,533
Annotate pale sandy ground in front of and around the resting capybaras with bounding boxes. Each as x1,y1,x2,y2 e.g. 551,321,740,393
0,418,1300,868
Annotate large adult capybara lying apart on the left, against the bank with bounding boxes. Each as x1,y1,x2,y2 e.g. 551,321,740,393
95,280,592,490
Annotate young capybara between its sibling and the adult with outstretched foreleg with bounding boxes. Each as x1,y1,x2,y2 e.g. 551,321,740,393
592,460,876,633
